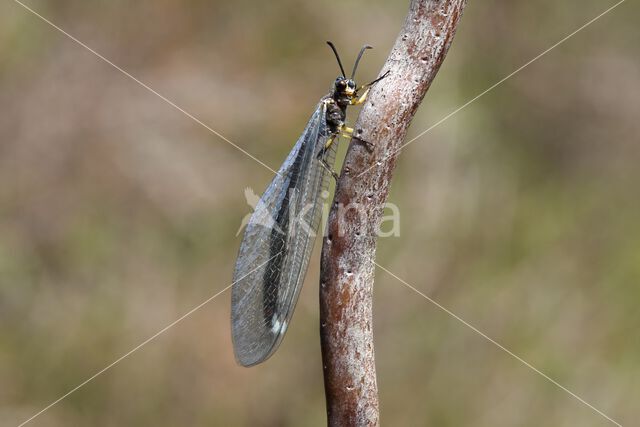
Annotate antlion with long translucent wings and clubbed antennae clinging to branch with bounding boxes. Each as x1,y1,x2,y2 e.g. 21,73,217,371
231,42,388,366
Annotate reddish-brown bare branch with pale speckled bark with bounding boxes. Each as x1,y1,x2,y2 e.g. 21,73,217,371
320,0,467,426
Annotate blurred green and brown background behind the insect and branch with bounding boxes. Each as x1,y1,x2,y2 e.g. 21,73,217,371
0,0,640,426
